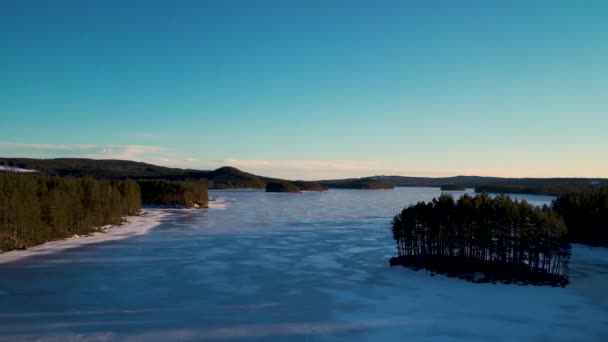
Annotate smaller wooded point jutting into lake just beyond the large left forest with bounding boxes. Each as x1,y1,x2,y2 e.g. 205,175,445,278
137,179,209,208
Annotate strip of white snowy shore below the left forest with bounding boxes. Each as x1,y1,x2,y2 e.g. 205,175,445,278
0,209,169,264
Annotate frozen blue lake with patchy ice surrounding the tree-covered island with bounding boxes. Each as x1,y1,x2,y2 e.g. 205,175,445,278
0,188,608,341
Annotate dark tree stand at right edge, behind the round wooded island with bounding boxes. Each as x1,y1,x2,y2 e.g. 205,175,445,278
552,187,608,247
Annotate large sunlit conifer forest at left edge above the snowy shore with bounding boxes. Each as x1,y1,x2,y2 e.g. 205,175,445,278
0,172,140,251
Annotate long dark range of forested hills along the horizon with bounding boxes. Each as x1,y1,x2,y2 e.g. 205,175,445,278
0,158,608,195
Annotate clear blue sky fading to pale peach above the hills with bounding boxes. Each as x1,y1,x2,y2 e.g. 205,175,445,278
0,0,608,179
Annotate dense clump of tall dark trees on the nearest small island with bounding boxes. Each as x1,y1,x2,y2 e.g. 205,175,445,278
391,194,570,285
